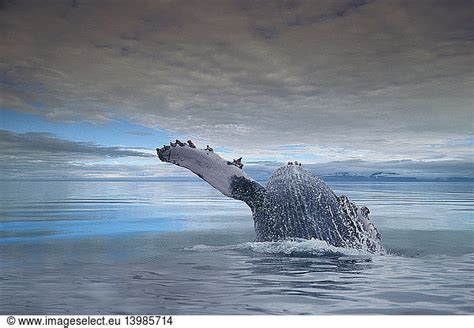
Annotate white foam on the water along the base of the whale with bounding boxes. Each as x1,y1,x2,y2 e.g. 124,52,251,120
184,239,374,257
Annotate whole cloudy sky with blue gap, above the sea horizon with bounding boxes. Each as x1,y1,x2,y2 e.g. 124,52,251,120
0,0,474,178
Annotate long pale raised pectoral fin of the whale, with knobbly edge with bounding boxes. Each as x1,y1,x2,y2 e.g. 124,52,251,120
156,140,265,209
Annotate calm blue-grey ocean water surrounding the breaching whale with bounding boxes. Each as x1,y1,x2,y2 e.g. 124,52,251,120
0,180,474,314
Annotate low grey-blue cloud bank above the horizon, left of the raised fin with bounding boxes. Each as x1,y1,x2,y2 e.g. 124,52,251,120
0,130,168,179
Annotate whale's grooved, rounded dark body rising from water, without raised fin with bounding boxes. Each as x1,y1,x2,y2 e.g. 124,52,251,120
253,165,380,252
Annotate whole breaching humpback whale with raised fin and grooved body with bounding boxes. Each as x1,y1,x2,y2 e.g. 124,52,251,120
156,140,383,253
